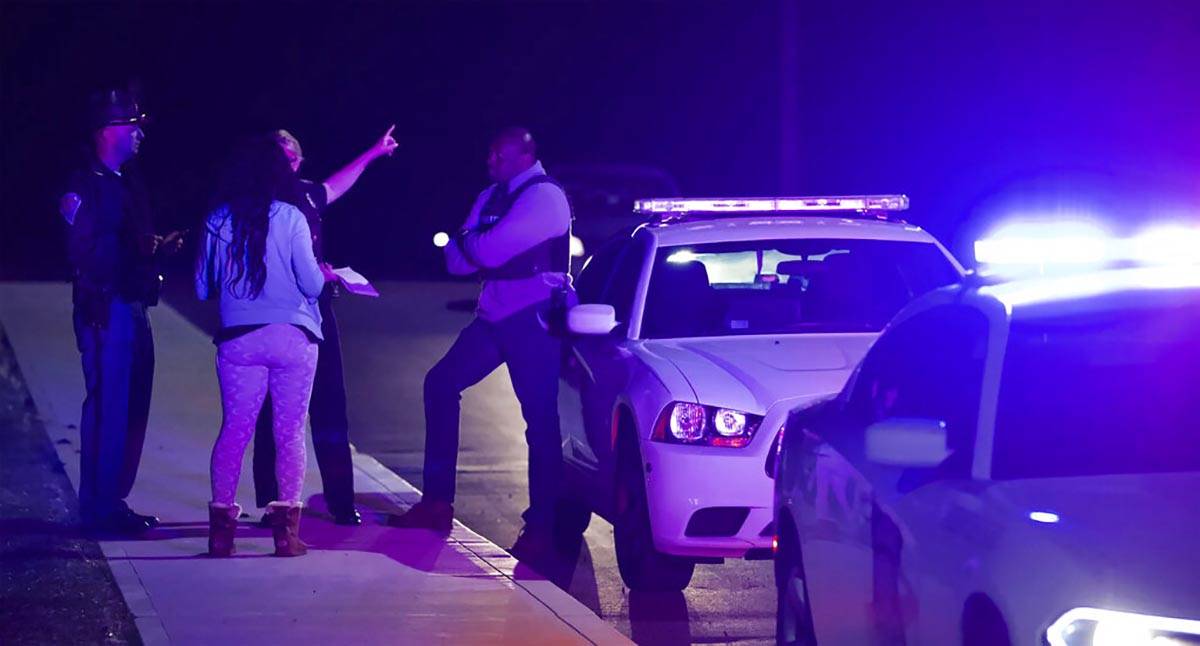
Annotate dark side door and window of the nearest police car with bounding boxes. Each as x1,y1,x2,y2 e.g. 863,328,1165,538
798,305,985,645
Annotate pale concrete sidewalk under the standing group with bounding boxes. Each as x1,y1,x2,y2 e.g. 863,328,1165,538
0,283,628,644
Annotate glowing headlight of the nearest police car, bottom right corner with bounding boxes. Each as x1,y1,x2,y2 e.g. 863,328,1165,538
1046,608,1200,646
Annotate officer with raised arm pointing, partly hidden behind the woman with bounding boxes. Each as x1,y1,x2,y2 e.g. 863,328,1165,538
254,126,398,525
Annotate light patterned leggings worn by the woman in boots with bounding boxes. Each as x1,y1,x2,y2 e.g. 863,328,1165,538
211,323,318,504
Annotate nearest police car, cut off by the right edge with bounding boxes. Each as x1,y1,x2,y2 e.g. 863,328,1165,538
774,267,1200,646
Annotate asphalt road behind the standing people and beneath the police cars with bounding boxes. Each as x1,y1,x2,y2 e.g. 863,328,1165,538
168,282,775,644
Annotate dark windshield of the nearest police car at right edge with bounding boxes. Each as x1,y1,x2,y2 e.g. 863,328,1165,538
992,293,1200,479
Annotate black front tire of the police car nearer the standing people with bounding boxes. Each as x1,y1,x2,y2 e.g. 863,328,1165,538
613,434,696,592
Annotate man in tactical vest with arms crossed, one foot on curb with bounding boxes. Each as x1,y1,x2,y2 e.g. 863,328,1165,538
389,127,571,560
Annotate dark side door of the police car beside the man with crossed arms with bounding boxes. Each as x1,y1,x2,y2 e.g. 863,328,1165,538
559,239,649,503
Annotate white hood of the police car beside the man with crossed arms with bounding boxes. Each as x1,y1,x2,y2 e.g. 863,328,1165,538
643,334,877,414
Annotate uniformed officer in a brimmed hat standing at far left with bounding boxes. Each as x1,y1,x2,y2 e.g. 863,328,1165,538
59,90,182,533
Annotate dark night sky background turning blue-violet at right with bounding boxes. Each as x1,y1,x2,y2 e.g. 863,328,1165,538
0,0,1200,279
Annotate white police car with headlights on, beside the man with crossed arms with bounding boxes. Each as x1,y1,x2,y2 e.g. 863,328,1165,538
559,196,961,590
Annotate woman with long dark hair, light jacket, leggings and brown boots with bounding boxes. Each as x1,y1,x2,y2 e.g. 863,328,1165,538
196,138,334,556
